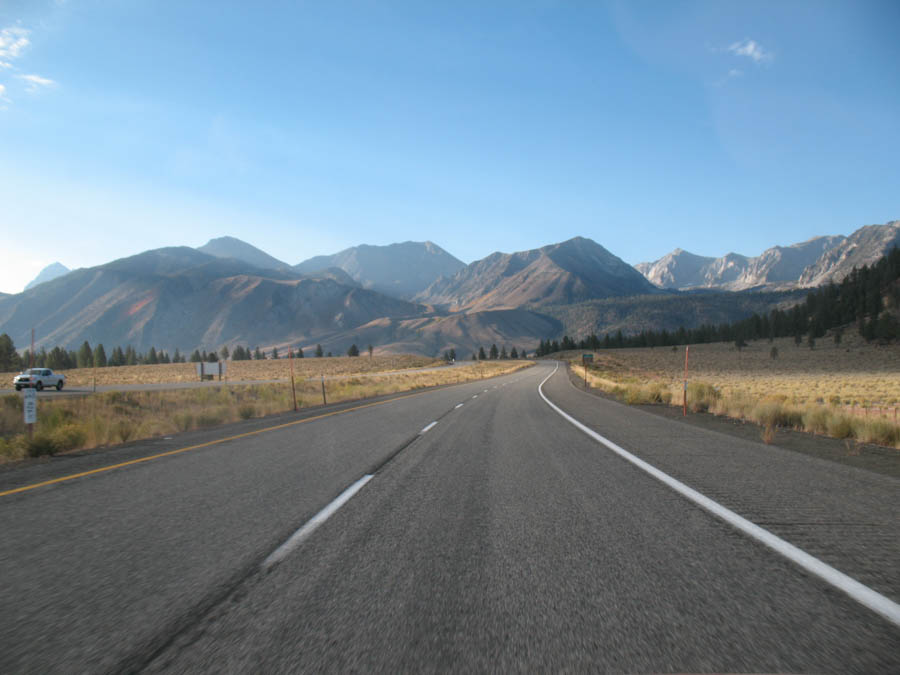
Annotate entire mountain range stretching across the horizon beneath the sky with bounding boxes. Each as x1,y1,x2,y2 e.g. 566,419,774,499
0,221,900,355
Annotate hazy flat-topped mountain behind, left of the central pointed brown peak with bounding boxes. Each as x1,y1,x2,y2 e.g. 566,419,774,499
294,241,464,298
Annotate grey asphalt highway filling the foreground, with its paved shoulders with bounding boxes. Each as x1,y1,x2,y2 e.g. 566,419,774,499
0,364,900,673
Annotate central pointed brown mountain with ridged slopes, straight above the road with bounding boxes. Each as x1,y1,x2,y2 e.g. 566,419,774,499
415,237,656,311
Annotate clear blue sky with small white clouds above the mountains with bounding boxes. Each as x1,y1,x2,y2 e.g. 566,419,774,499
0,0,900,292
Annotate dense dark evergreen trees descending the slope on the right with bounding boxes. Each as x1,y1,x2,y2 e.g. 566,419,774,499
536,247,900,356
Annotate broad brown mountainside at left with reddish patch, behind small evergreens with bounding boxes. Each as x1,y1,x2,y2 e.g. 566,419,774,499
0,247,424,351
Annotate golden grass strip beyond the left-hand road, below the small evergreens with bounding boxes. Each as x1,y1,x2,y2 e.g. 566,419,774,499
0,354,444,388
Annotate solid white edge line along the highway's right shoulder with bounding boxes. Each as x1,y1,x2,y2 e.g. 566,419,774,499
538,362,900,626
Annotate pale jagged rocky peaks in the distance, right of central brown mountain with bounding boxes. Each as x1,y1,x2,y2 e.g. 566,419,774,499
635,235,845,291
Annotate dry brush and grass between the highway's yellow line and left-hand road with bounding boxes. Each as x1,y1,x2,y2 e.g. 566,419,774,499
0,361,532,462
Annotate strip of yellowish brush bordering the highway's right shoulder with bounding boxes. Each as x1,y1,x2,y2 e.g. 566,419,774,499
568,359,900,449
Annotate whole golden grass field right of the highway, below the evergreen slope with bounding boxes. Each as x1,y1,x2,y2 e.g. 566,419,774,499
566,331,900,447
